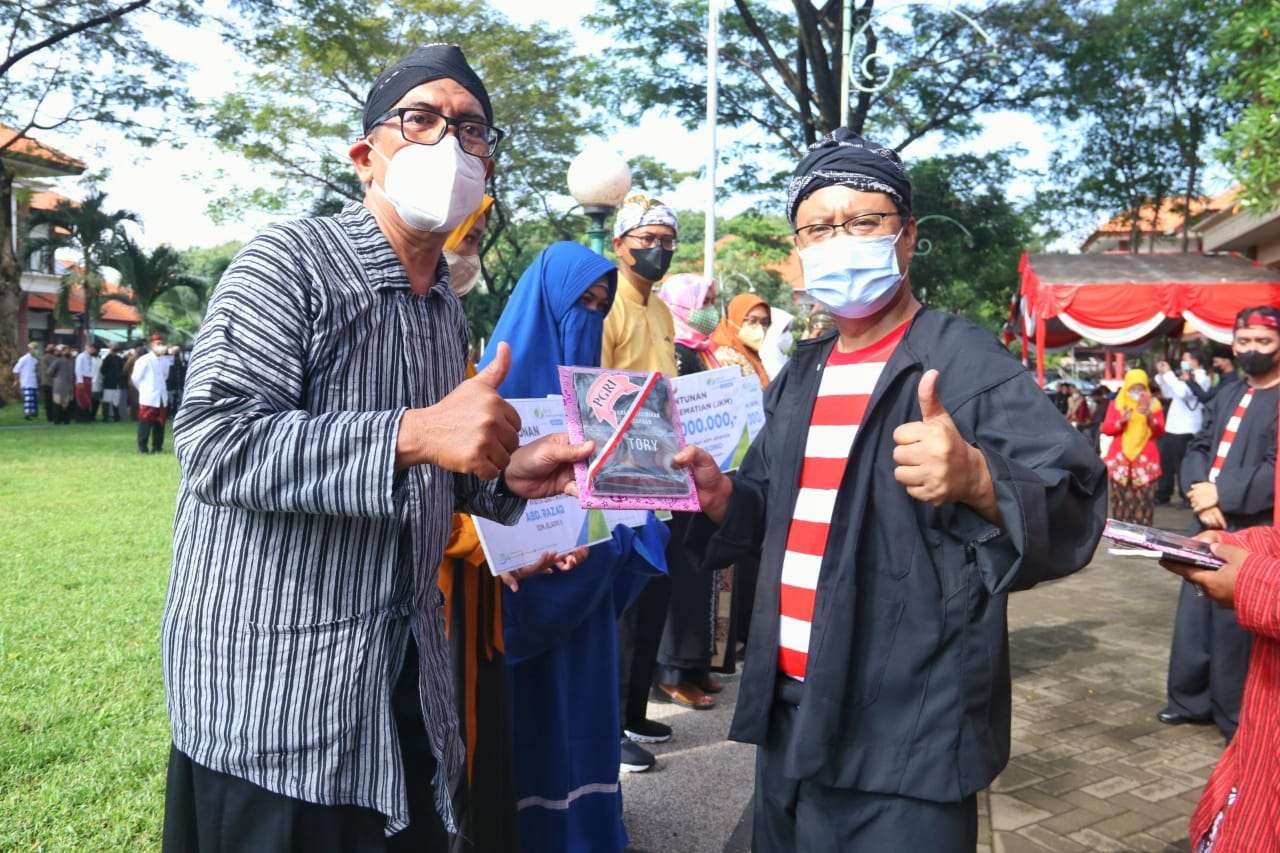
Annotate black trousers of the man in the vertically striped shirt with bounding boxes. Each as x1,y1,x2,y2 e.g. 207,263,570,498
163,640,449,853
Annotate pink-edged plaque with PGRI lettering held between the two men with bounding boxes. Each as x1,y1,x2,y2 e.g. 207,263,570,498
559,368,700,512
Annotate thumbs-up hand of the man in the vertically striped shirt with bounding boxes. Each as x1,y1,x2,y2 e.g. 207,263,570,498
396,343,520,480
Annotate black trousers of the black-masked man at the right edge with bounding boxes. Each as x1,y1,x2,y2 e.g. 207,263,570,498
1169,581,1253,740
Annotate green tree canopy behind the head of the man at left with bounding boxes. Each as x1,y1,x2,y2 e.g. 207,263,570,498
207,0,604,338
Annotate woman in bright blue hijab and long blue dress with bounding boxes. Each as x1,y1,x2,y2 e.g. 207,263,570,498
480,236,668,853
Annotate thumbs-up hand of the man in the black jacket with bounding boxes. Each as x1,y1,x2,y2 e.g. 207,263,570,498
893,370,998,521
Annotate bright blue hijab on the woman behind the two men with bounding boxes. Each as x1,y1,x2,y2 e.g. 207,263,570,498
480,242,618,400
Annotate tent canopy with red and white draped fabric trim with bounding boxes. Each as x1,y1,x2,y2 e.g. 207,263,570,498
1016,252,1280,384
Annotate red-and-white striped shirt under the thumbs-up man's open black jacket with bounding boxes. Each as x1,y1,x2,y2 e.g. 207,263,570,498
778,321,910,681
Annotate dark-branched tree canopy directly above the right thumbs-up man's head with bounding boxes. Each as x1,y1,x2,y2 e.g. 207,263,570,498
588,0,1078,191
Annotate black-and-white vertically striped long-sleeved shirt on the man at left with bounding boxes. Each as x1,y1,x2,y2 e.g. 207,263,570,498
163,204,522,834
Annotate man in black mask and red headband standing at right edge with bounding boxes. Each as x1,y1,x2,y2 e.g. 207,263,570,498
1156,306,1280,739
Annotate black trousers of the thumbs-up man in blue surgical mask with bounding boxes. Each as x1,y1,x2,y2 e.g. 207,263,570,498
751,702,978,853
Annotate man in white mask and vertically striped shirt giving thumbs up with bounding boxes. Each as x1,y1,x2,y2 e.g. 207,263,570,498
163,45,590,853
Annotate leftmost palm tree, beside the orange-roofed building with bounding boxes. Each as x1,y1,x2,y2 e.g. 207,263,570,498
27,190,138,341
